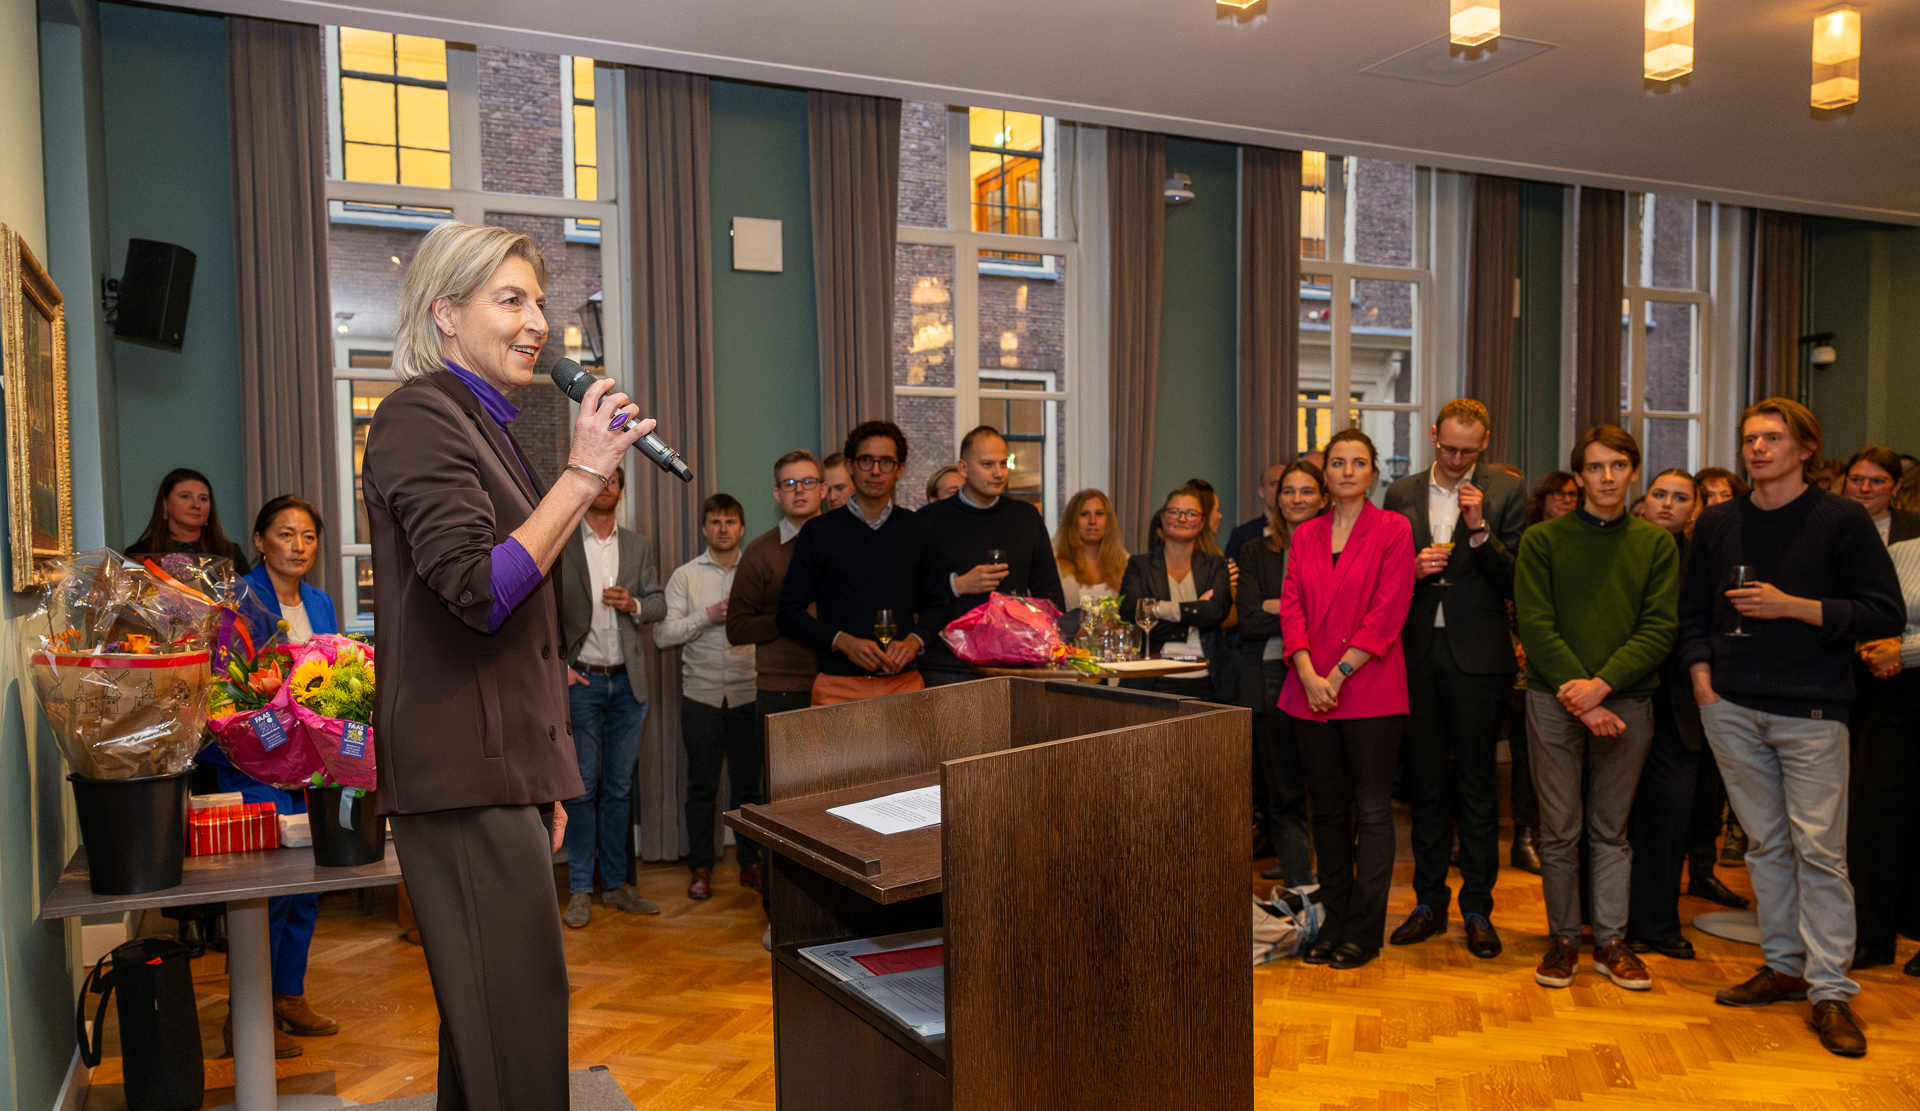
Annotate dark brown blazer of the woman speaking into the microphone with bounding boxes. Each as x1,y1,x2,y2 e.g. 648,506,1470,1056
361,370,584,814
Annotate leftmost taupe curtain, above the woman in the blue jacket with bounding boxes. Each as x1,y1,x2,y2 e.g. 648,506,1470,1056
227,15,339,598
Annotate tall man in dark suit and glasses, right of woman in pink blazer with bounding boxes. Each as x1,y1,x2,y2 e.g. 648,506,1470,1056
1386,397,1526,957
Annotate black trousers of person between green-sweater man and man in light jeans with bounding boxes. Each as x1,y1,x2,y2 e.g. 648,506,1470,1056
1626,691,1699,942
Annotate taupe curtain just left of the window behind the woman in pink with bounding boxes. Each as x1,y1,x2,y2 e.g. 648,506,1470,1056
1236,146,1300,520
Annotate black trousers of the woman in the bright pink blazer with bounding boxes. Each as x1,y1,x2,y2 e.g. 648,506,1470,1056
1294,714,1407,950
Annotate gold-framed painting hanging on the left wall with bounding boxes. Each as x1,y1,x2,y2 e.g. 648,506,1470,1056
0,225,73,591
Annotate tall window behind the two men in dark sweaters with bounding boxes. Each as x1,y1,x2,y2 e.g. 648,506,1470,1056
893,102,1077,520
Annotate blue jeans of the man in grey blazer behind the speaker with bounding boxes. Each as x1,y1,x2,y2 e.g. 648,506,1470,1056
566,672,647,894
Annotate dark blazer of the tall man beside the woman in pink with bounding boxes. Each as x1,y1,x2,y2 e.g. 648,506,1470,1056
1382,462,1526,675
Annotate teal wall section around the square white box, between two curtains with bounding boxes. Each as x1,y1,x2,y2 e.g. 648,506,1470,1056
710,81,820,537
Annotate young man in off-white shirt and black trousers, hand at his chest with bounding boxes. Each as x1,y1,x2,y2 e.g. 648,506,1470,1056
653,493,766,898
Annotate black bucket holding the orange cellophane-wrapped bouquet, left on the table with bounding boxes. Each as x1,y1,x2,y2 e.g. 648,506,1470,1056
67,764,194,894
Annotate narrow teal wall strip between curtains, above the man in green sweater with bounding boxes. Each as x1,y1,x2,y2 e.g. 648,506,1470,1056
1507,182,1567,476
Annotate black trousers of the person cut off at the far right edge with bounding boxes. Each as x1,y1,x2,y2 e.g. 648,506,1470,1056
1847,672,1920,961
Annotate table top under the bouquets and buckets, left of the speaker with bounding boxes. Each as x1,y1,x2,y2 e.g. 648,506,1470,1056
40,842,399,921
